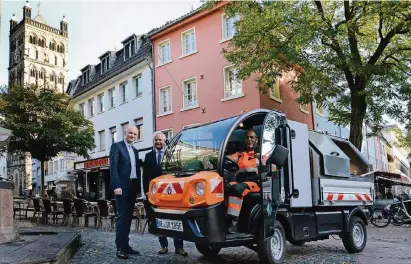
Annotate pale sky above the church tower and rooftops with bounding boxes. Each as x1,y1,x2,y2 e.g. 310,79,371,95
0,0,204,86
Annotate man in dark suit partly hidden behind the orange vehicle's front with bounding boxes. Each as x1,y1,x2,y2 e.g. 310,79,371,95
143,131,188,256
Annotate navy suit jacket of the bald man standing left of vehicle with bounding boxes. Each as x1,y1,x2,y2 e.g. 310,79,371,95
110,141,141,195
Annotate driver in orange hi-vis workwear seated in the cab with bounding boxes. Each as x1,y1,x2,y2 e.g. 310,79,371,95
227,129,260,233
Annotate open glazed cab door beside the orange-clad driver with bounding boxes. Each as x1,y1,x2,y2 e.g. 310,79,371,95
261,111,289,239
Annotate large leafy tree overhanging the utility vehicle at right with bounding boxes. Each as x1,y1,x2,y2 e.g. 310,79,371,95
214,1,411,149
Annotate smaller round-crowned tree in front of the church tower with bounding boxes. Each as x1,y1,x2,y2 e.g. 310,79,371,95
0,85,95,196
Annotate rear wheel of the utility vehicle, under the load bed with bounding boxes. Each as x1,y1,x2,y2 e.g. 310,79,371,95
341,216,367,253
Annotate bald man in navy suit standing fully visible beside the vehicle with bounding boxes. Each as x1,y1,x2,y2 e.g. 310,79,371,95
110,126,141,259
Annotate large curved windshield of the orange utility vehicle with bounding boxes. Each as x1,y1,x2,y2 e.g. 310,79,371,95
163,116,238,174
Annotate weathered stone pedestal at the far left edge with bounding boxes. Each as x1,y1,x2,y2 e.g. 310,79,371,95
0,181,16,244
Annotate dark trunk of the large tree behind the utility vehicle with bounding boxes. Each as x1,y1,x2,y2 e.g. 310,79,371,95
350,90,367,151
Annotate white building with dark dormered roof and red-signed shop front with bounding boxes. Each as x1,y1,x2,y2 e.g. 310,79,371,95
68,35,155,200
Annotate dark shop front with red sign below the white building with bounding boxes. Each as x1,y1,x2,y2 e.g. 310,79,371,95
72,156,114,201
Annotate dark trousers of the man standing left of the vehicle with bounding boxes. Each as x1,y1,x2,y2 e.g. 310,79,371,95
115,179,141,252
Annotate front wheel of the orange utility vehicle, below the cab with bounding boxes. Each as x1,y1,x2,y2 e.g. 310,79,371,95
258,220,287,264
